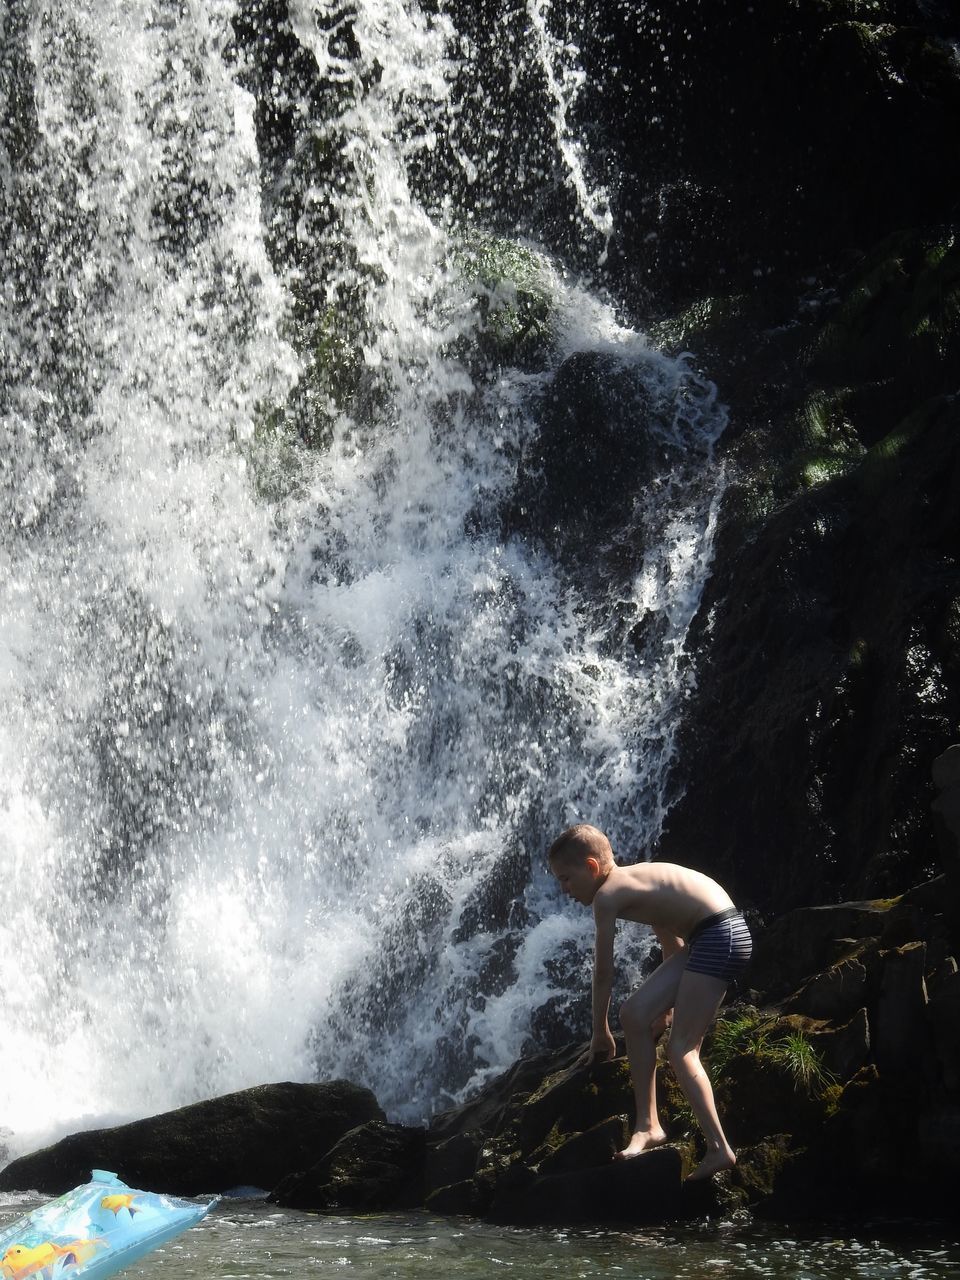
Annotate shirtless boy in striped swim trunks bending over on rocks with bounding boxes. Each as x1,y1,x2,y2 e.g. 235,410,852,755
549,823,751,1181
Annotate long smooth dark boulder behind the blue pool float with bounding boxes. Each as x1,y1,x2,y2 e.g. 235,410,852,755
0,1080,384,1196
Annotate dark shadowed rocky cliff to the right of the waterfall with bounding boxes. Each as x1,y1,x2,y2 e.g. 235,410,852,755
237,0,960,911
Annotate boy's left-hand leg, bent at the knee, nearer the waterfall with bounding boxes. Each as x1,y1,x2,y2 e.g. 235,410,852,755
617,951,686,1160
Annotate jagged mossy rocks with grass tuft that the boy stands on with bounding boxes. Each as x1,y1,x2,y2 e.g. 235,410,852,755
419,882,960,1225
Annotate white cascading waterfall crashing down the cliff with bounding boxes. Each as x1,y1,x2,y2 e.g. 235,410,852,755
0,0,723,1155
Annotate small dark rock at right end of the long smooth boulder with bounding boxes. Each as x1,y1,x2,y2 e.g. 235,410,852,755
269,1120,426,1213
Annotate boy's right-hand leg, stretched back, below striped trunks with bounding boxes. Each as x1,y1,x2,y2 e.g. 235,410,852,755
667,973,736,1180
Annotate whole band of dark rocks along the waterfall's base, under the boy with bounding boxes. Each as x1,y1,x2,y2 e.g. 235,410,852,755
0,876,960,1226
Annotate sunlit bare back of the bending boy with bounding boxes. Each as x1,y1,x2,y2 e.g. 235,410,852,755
593,863,733,938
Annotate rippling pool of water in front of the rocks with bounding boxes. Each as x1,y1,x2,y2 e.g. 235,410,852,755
0,1196,960,1280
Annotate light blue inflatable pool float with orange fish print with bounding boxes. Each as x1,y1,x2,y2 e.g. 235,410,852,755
0,1169,219,1280
